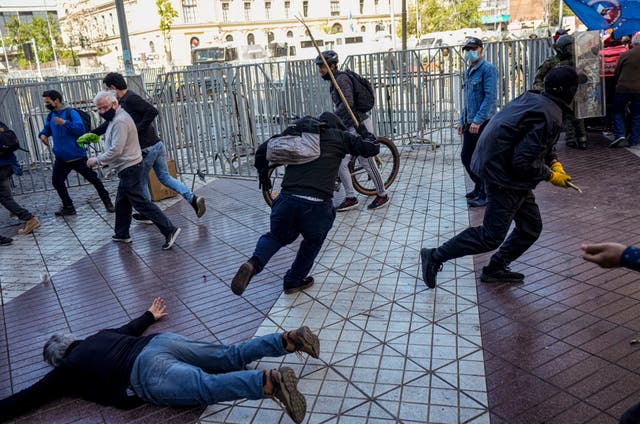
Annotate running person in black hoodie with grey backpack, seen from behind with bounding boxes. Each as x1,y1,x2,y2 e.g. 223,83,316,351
231,112,380,296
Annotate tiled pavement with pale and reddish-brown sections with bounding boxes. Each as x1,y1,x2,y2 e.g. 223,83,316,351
0,137,640,423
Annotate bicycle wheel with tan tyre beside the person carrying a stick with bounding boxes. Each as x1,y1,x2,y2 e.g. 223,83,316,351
349,137,400,196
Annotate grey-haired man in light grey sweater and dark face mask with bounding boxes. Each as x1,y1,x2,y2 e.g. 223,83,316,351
87,91,182,250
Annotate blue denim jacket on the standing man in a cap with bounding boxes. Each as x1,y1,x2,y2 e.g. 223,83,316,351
459,58,498,125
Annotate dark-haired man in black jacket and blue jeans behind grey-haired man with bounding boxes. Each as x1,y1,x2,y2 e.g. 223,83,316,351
91,72,207,224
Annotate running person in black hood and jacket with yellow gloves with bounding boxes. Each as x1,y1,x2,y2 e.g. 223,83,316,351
420,66,584,288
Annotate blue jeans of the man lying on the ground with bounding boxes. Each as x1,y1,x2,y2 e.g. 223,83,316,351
131,333,288,406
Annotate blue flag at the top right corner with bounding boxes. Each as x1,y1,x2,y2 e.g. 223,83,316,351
564,0,640,38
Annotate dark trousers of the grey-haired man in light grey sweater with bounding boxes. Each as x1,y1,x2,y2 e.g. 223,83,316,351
116,162,175,238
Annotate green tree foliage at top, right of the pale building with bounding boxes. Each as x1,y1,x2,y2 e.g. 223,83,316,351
407,0,481,36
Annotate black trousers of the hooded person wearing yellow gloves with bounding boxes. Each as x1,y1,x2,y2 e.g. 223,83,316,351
433,184,542,269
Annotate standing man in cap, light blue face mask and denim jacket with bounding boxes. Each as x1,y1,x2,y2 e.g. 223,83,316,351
458,37,498,207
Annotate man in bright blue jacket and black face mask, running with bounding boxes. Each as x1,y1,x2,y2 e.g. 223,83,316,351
38,90,115,216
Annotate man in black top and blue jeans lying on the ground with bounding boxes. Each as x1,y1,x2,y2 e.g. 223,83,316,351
0,297,320,423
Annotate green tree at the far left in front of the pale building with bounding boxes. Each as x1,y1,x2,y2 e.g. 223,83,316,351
4,14,68,67
